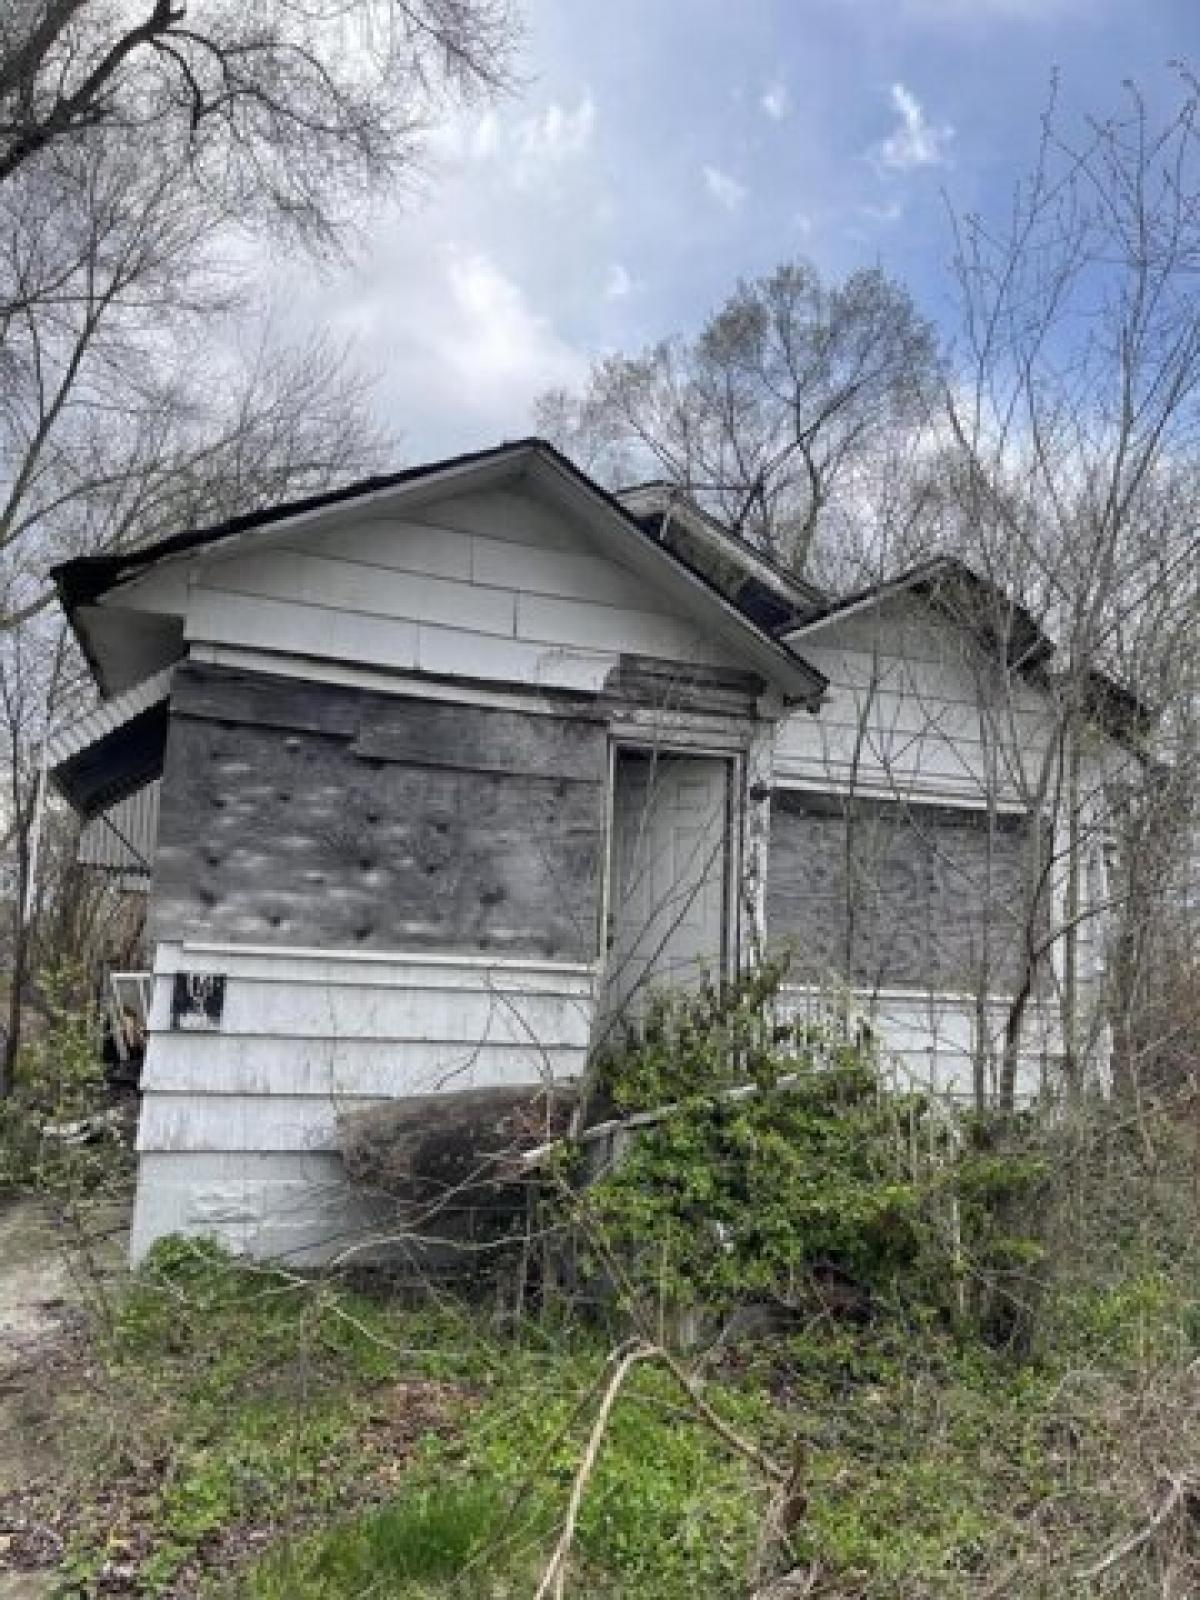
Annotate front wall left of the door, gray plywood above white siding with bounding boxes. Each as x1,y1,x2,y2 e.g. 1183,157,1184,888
133,664,608,1256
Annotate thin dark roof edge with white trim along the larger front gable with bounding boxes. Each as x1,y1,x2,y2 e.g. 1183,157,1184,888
50,435,829,709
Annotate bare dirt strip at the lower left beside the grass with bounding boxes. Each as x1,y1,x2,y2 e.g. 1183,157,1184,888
0,1198,128,1600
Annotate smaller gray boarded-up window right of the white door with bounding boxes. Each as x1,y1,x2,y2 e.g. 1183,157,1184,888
766,790,1035,992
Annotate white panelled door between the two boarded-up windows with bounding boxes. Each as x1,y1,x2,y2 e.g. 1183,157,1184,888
603,750,731,1024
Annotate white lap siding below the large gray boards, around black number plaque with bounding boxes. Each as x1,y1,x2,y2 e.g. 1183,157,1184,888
131,942,594,1259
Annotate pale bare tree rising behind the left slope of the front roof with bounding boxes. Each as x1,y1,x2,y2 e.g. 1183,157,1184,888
0,133,382,1080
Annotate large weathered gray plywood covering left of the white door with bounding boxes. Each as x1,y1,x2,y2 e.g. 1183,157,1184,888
152,664,606,962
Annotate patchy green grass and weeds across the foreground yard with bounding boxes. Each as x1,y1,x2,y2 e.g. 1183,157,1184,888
16,1120,1200,1600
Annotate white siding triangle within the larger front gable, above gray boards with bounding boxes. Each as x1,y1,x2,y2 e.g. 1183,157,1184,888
127,490,742,690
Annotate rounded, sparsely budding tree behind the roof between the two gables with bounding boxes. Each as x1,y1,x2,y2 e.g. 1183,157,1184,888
538,261,938,571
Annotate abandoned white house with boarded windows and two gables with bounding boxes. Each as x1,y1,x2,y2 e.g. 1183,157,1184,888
42,440,1128,1254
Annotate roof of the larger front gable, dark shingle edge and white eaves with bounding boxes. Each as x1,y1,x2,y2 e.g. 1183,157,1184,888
51,437,827,707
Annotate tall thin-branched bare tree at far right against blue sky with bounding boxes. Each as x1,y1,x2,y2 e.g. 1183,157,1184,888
947,75,1200,1100
